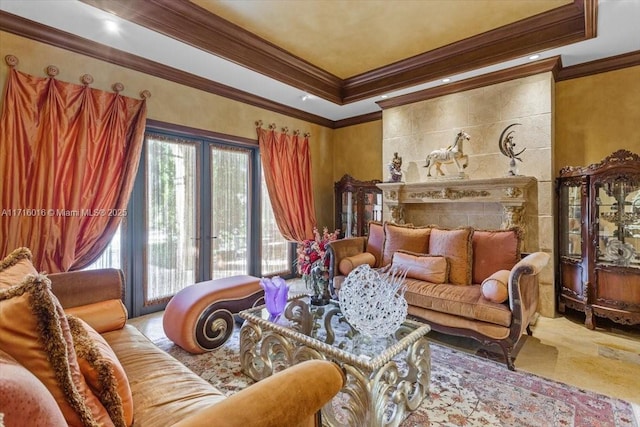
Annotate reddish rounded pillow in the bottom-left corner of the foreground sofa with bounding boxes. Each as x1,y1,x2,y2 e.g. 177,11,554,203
0,350,67,427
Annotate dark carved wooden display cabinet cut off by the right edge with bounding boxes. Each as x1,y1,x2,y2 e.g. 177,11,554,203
556,150,640,329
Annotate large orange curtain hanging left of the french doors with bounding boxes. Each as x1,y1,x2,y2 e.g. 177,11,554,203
0,68,146,273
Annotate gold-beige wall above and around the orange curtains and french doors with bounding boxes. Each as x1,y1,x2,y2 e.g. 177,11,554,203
0,32,333,231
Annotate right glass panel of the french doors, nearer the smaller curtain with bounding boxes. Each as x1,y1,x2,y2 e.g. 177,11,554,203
210,146,251,279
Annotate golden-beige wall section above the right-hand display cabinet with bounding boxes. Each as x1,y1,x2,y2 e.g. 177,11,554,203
554,66,640,171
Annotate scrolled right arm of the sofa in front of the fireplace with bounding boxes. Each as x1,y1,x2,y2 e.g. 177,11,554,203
509,252,551,339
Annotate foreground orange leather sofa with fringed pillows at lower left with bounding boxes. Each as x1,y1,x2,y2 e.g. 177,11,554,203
0,248,344,427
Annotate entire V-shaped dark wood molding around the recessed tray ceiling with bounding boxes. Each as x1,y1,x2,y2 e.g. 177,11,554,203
81,0,597,105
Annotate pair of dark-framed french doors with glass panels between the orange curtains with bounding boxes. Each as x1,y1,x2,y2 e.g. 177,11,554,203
142,133,255,311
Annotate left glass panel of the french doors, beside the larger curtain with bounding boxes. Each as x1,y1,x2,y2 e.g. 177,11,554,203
143,136,200,306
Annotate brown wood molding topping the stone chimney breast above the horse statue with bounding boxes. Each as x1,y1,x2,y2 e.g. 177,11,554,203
377,56,561,110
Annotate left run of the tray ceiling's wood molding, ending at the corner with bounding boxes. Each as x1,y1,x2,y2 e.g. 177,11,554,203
80,0,342,104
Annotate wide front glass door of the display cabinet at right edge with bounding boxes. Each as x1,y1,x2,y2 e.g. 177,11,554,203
596,181,640,267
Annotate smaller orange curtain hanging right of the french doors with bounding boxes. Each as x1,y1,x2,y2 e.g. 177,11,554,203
257,127,316,242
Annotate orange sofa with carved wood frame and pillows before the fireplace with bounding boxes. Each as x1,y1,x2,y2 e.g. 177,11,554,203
328,222,549,370
